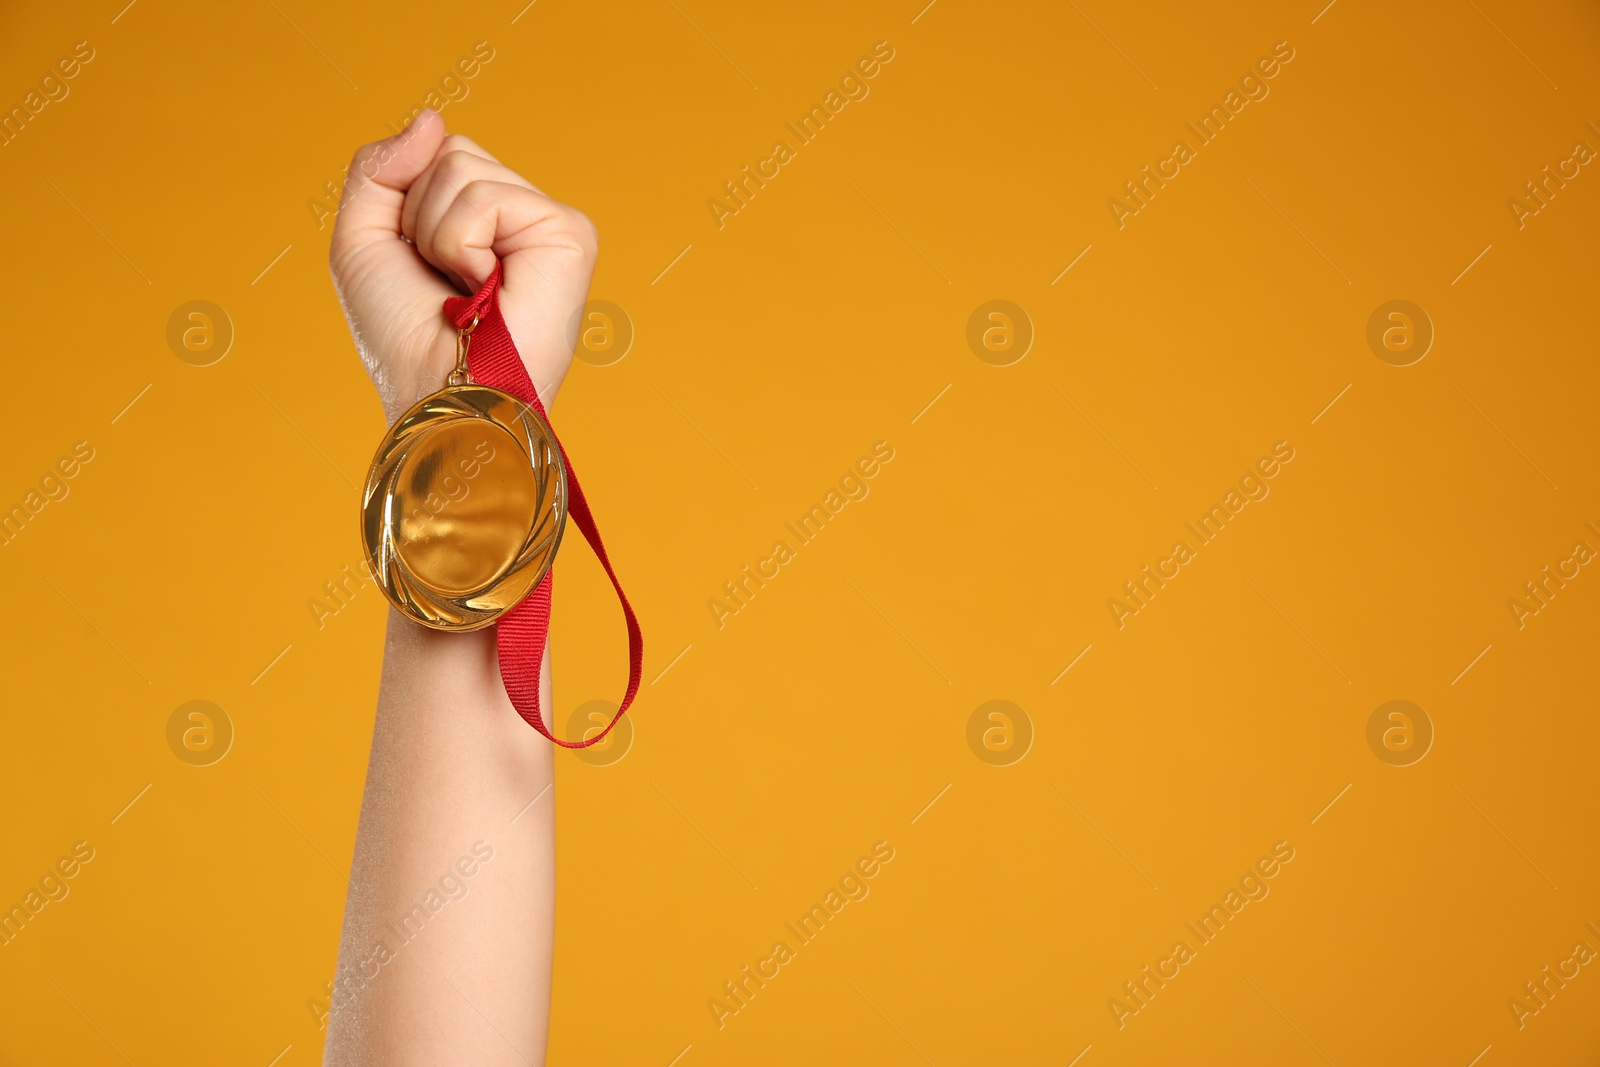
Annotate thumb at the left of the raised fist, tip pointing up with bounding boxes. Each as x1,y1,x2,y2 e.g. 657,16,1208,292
330,110,445,271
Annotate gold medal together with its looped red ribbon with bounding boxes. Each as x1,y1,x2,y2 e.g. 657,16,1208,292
362,266,643,749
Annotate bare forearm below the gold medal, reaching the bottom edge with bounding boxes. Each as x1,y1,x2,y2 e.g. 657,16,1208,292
325,611,555,1067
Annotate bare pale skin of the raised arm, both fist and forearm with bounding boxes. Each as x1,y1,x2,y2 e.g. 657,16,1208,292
323,112,597,1067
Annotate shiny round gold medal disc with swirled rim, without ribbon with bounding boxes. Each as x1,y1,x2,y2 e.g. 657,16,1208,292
362,386,566,630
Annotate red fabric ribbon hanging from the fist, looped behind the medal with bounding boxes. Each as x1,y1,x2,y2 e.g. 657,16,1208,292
445,264,645,749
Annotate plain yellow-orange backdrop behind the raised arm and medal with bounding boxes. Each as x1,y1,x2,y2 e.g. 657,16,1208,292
0,0,1600,1067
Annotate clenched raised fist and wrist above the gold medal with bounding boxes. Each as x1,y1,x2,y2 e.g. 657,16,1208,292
328,110,597,421
